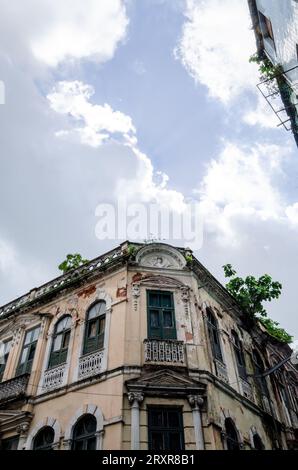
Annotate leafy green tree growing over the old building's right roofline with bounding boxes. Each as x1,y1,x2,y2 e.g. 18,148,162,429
223,264,292,343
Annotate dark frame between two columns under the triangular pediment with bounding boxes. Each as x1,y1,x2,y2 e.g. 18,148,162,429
147,405,185,452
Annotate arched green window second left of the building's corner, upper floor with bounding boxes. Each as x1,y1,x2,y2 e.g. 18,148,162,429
49,315,71,367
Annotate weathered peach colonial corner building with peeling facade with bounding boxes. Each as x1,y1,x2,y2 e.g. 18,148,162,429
0,242,298,451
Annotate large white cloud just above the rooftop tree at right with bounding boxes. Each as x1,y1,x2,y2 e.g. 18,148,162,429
197,142,298,245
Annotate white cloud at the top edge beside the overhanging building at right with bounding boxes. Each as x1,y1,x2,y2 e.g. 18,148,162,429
176,0,257,103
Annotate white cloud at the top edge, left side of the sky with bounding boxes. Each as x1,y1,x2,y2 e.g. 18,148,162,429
31,0,128,67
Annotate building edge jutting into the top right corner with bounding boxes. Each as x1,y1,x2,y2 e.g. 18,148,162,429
248,0,298,145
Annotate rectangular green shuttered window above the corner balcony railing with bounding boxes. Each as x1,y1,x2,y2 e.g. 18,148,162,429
147,291,177,339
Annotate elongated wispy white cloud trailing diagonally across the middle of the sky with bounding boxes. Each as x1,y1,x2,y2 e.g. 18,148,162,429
47,81,185,211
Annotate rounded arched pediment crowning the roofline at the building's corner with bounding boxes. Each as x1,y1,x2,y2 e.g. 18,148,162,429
136,243,186,269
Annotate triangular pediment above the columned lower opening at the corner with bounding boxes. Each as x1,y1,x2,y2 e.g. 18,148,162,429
126,369,205,395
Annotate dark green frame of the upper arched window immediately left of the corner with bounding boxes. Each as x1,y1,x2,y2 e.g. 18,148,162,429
82,299,107,356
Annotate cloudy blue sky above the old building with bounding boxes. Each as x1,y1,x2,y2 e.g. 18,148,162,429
0,0,298,339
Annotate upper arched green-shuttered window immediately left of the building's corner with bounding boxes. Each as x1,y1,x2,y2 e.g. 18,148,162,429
83,300,106,354
